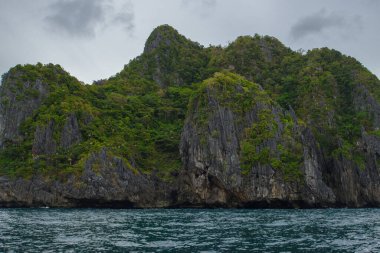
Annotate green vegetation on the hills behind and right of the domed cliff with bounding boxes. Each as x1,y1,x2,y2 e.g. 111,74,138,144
211,38,380,171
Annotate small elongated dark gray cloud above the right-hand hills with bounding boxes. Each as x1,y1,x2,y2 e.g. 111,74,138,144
290,9,361,40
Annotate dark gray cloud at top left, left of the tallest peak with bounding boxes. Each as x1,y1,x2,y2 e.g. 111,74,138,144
44,0,135,38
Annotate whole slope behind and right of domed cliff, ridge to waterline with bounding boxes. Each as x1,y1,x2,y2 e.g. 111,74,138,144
205,36,380,206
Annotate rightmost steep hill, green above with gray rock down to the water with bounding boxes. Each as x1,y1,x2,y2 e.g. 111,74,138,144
297,49,380,205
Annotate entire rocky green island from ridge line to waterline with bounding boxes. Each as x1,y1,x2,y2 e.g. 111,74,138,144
0,25,380,207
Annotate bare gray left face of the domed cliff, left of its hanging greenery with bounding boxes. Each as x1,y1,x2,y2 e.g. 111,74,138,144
180,105,242,204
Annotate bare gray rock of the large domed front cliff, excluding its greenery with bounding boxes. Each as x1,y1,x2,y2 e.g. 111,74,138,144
178,77,335,206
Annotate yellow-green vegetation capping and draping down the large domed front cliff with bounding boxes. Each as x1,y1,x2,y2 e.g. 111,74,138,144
189,71,303,181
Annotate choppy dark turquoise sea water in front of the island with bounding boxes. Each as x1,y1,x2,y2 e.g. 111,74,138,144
0,209,380,252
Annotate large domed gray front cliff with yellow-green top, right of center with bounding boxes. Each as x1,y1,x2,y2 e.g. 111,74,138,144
179,72,335,206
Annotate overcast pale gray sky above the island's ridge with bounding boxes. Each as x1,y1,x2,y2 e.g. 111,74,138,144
0,0,380,83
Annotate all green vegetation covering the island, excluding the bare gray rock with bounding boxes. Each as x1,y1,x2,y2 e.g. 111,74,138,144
0,25,380,180
